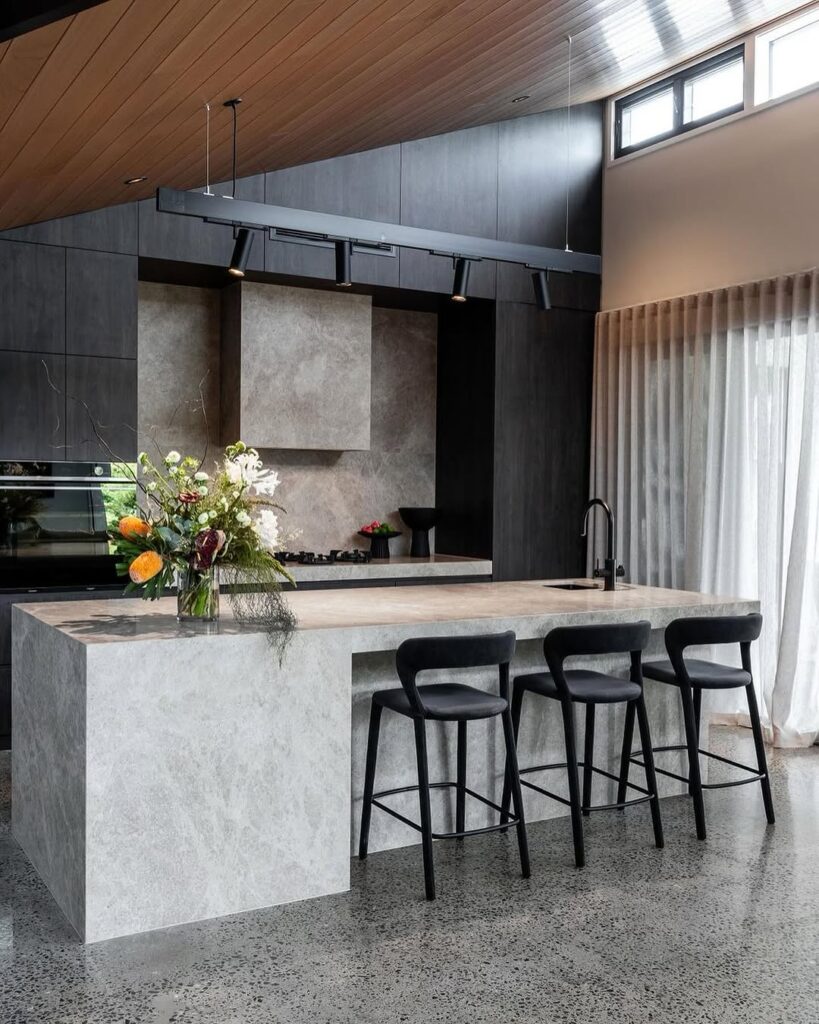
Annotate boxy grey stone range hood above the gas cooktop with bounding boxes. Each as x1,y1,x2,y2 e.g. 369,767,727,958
220,281,373,452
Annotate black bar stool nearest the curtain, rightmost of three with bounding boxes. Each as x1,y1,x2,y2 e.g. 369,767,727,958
621,612,775,839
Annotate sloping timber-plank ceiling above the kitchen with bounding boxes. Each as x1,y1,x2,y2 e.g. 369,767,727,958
0,0,804,228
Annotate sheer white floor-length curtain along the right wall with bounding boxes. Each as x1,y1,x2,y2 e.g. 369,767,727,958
591,270,819,746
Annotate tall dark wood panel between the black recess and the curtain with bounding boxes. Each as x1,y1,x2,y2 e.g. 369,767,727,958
494,302,594,580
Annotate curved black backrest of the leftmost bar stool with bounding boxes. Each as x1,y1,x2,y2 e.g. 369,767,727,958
395,630,515,715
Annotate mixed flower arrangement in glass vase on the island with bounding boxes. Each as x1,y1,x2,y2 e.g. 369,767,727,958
113,441,295,640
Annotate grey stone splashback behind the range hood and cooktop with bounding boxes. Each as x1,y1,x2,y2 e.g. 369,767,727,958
139,292,437,555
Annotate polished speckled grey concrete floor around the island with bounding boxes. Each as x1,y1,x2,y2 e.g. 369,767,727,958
0,729,819,1024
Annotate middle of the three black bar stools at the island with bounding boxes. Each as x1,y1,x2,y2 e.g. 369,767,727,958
502,622,663,867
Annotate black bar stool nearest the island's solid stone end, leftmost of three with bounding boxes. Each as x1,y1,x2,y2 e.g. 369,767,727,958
358,632,529,899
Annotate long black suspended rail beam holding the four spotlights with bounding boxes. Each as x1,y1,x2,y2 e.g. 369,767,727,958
157,188,601,274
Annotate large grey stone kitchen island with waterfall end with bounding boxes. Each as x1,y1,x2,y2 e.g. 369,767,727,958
12,581,758,942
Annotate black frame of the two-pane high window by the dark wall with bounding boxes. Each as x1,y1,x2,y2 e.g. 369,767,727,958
613,40,748,160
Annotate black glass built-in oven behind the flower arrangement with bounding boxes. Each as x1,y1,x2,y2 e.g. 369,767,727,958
0,462,137,590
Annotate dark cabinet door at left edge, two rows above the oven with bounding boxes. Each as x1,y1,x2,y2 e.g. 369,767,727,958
0,241,66,352
